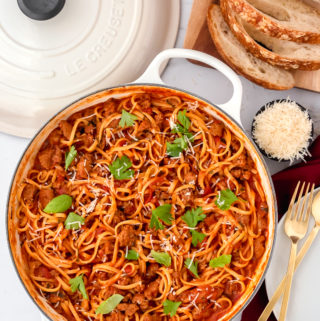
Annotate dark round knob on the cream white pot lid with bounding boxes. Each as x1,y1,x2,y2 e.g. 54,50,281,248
18,0,65,20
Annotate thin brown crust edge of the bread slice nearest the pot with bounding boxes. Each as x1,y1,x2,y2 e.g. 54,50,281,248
207,4,294,90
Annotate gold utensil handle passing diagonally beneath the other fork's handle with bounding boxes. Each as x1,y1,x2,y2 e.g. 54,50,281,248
258,225,319,321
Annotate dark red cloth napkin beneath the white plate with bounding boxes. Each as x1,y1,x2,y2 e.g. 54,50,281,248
241,136,320,321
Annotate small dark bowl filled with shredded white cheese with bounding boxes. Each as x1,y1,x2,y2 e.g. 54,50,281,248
252,99,313,162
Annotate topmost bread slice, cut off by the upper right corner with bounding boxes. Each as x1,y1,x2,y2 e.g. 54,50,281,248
229,0,320,43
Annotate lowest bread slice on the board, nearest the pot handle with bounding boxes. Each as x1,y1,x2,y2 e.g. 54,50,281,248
207,4,294,90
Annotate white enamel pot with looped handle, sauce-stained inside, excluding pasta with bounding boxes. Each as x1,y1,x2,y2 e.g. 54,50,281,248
7,49,277,321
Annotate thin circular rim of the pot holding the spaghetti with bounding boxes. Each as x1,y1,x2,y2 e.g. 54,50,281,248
6,83,278,321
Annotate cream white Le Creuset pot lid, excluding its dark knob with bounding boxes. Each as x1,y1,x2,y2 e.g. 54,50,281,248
0,0,180,137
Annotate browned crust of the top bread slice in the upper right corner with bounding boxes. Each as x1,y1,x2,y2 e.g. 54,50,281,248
228,0,320,44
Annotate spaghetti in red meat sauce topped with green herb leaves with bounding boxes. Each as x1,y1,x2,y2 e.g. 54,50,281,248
16,92,268,321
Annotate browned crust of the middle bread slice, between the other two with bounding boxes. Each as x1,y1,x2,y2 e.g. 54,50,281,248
220,0,320,70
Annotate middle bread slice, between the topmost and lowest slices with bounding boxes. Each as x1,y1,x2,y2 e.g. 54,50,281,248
220,0,320,70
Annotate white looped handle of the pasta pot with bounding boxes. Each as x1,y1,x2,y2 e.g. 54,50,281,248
134,48,242,126
